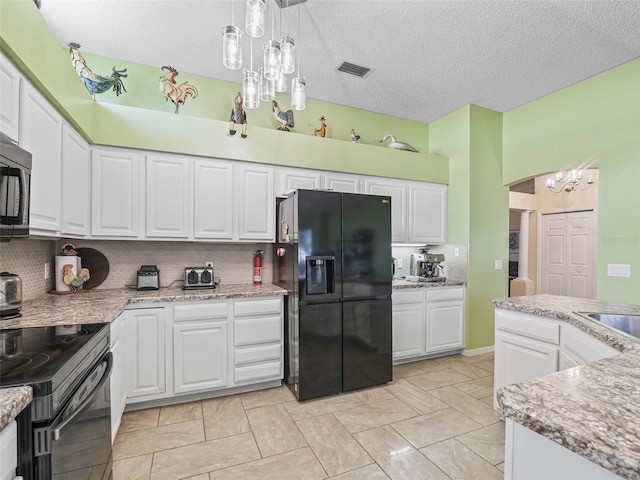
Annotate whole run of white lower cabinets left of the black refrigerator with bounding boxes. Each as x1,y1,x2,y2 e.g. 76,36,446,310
123,296,283,403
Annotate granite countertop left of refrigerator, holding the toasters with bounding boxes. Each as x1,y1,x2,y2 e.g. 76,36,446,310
0,284,287,330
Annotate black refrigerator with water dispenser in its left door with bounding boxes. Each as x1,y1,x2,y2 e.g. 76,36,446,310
273,190,392,400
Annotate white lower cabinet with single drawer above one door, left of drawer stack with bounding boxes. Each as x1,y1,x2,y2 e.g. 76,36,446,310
173,300,229,394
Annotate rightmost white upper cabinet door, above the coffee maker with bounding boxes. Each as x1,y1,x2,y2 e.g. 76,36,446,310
409,182,447,245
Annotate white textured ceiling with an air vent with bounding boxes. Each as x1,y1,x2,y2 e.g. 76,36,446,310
40,0,640,122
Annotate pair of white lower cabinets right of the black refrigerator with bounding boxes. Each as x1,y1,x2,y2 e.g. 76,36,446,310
392,287,464,361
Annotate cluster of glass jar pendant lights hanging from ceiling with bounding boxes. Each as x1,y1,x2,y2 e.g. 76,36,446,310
222,0,307,110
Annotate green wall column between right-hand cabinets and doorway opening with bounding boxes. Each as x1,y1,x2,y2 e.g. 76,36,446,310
429,105,509,349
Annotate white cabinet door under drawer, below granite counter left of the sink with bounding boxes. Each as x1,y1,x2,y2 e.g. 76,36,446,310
494,332,559,400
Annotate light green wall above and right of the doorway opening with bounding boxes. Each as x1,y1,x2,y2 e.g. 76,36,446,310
503,59,640,304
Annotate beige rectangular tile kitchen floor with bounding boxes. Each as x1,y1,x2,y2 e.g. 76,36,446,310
113,354,504,480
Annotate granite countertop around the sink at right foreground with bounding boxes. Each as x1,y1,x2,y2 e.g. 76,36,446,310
493,295,640,479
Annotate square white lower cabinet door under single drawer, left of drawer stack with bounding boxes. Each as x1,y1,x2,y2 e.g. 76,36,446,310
173,319,229,393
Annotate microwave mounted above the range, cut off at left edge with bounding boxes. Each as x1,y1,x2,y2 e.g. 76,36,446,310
0,138,31,242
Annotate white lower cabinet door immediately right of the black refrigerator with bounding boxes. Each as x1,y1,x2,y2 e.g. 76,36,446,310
393,296,424,360
